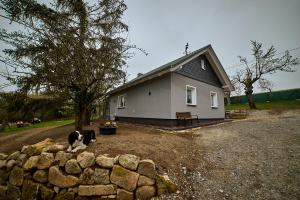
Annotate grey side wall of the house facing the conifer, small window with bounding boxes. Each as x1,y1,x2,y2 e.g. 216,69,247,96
109,74,171,119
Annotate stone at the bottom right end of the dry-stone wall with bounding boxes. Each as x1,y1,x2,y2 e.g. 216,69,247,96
156,175,178,195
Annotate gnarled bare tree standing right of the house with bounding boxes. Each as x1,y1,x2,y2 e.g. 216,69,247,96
232,41,299,109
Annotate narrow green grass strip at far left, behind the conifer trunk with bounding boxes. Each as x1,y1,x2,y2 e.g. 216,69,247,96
2,119,74,133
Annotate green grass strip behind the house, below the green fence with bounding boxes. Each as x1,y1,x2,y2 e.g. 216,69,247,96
225,100,300,110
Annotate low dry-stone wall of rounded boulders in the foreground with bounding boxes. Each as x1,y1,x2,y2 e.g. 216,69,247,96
0,139,177,200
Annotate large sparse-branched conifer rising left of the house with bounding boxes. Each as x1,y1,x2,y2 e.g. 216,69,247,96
0,0,145,130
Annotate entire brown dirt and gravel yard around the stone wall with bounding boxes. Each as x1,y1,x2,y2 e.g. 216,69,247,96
0,110,300,200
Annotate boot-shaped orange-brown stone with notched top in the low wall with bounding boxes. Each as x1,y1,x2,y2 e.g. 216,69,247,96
48,166,78,188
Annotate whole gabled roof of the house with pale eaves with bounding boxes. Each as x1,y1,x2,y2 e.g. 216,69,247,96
109,44,234,94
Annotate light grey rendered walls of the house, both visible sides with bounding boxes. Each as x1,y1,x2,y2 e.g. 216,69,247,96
109,73,225,119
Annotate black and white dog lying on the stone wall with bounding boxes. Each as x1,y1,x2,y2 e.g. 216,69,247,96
67,130,96,152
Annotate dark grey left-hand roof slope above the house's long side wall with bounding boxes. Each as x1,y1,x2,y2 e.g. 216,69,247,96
109,44,211,94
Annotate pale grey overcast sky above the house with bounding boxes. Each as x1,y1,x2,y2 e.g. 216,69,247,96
0,0,300,91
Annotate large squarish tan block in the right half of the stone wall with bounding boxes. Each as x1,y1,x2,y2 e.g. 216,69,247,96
110,165,139,191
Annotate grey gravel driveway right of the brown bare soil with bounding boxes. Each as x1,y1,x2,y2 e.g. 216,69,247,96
162,110,300,200
